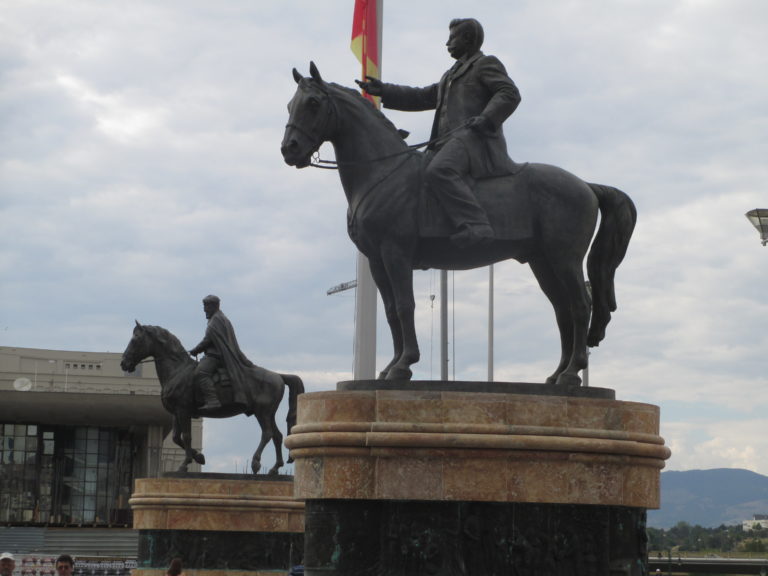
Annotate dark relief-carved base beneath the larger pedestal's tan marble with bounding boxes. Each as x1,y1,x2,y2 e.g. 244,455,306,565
304,500,647,576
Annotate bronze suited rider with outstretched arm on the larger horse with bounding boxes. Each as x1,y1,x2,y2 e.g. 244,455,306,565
357,18,520,247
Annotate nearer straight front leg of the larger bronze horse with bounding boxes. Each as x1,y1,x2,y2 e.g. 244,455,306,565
382,246,421,380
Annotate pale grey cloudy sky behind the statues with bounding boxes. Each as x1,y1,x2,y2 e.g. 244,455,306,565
0,0,768,474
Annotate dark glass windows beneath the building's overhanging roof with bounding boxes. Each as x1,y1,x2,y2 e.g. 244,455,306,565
0,423,135,525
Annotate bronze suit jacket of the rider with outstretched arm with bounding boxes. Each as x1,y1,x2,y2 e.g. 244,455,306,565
381,51,520,178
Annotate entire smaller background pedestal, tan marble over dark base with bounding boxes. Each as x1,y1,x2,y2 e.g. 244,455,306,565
130,473,304,576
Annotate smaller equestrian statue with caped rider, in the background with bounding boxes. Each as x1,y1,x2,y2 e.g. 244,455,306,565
120,297,304,474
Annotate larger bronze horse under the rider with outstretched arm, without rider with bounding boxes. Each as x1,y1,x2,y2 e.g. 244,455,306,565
281,63,637,386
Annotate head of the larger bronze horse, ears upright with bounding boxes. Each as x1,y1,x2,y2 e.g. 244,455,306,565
280,62,335,168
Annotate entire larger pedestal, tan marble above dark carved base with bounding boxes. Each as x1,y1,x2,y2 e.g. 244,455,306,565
286,381,670,576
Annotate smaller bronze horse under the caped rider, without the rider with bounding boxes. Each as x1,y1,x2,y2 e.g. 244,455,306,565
120,322,304,474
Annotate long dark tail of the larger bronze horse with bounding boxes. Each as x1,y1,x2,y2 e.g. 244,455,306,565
587,184,637,346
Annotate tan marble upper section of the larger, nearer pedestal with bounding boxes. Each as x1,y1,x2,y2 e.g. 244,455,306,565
285,381,670,508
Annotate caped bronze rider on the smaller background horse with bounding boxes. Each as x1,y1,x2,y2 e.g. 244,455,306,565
189,295,254,410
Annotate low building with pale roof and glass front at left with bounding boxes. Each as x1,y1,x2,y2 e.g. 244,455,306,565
0,346,202,527
